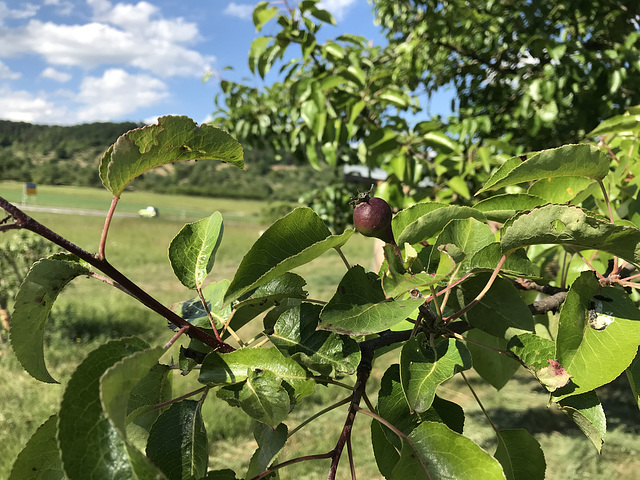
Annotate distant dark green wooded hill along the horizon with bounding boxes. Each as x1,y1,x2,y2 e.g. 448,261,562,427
0,120,330,201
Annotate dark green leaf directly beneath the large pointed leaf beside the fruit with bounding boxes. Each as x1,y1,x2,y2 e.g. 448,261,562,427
229,272,308,330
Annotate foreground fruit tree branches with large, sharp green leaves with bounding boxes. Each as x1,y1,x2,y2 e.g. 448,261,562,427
0,107,640,480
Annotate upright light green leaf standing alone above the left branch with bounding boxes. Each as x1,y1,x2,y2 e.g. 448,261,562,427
169,212,224,289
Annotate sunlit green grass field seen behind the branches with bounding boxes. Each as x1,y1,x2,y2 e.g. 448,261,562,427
0,182,640,480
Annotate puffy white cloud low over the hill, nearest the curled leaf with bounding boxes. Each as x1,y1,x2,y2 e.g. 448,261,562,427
76,68,169,122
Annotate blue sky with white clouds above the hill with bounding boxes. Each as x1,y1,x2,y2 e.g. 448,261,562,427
0,0,448,125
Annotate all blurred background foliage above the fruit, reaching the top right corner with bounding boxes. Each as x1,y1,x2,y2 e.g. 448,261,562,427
216,0,640,220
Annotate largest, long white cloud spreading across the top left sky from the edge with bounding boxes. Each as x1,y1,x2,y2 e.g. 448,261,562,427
0,0,215,77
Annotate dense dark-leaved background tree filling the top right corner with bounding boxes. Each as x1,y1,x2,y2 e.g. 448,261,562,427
374,0,640,149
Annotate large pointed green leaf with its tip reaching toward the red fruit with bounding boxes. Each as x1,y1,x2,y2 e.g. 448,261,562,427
225,208,354,303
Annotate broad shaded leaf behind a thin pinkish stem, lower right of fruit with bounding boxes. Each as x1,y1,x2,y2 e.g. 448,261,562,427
461,272,534,340
